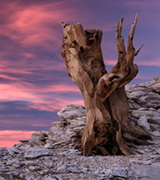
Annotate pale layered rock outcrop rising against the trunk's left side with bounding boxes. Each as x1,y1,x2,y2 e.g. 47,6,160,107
46,104,86,145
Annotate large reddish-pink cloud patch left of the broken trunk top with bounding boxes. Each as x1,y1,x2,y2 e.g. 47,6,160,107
0,1,87,51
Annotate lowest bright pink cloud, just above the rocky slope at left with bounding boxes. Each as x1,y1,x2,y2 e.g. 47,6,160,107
0,130,37,147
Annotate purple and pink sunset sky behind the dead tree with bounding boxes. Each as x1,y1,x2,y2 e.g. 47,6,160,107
0,0,160,147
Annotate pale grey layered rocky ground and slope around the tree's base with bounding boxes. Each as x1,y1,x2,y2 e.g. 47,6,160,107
0,78,160,180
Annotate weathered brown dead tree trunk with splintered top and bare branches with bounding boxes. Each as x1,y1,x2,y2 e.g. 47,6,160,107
62,15,149,155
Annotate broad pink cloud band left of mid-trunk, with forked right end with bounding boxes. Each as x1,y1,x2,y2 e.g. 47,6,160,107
0,79,83,111
